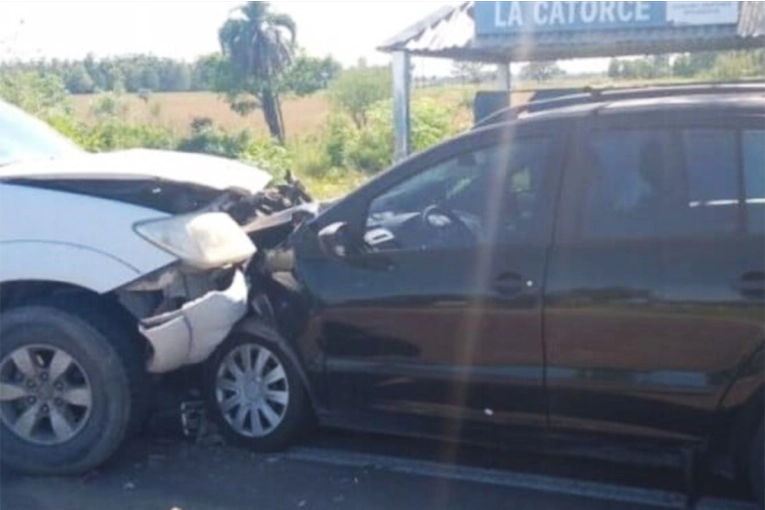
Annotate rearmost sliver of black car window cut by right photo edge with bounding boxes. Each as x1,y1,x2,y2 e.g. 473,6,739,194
741,129,765,233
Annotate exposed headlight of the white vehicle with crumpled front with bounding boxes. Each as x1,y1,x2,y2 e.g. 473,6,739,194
135,212,255,269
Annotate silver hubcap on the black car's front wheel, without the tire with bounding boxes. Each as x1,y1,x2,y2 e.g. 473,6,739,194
215,344,290,437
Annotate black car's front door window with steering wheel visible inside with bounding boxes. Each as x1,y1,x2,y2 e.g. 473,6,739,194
365,137,550,250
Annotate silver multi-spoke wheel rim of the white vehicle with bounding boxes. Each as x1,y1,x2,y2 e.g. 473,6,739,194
0,345,93,445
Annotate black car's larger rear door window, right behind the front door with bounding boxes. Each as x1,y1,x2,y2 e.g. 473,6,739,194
578,130,669,239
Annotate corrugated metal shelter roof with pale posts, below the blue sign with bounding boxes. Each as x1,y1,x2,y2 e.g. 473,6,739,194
378,0,765,160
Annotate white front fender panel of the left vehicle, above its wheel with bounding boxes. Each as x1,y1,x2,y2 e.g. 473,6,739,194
0,183,177,293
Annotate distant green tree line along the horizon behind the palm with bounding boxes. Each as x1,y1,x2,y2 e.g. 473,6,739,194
0,52,342,95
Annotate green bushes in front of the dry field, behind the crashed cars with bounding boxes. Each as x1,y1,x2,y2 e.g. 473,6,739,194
0,71,470,198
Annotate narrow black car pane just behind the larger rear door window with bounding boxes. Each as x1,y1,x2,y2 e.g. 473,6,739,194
674,129,739,235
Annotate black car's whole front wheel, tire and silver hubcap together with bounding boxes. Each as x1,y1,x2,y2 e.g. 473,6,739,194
204,335,312,452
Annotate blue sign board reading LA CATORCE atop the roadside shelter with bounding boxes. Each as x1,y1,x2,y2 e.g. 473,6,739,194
474,0,739,36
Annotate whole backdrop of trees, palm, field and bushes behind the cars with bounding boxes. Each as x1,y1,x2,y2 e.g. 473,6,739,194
0,0,765,198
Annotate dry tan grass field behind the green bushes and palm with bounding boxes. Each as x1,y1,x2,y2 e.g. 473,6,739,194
74,87,530,138
